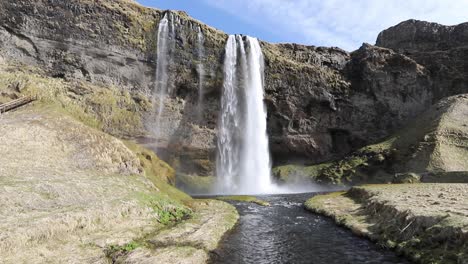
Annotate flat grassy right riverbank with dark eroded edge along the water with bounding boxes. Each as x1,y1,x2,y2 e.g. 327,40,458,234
305,183,468,264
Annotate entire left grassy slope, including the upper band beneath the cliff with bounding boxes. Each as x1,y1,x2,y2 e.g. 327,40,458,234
0,58,237,262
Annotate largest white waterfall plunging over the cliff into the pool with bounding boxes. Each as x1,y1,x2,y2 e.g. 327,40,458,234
216,35,273,194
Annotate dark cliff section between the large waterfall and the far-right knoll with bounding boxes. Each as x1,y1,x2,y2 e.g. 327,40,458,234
265,44,432,163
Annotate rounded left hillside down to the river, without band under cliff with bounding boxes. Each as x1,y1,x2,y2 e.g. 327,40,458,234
0,103,238,263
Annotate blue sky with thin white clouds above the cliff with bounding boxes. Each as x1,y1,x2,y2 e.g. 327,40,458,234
137,0,468,51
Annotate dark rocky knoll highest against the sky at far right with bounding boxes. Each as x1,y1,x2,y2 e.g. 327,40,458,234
376,20,468,99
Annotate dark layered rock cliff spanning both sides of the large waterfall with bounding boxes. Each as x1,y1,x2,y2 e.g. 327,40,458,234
0,0,468,175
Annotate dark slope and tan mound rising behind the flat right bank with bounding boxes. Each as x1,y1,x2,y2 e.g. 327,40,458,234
273,94,468,184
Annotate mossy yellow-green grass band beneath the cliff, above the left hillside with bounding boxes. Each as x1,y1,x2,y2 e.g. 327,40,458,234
0,60,151,137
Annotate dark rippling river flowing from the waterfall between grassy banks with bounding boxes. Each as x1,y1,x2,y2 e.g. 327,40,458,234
211,193,408,264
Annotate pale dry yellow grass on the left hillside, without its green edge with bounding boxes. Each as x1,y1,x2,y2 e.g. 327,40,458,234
0,107,177,263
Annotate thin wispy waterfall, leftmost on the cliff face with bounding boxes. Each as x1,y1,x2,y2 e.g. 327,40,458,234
155,13,174,137
